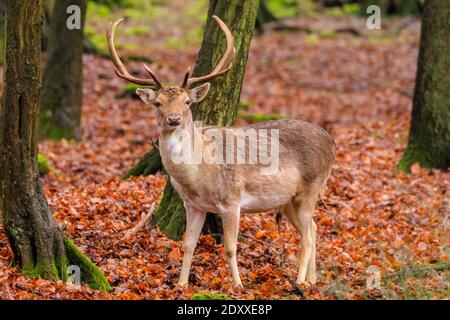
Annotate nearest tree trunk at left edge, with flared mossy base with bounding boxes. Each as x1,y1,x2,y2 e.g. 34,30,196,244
0,0,110,290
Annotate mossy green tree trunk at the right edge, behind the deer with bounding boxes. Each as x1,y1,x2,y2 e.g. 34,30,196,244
398,0,450,172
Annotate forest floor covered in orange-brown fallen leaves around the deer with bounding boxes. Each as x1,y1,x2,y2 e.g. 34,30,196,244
0,3,450,299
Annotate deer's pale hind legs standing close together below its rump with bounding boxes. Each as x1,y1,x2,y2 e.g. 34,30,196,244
283,192,317,284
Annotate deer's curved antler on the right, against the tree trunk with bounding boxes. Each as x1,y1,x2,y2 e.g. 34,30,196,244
186,15,236,88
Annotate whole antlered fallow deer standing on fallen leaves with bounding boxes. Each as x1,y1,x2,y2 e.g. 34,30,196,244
107,16,335,287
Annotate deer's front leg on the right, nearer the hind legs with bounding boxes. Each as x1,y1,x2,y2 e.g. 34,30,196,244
220,207,242,288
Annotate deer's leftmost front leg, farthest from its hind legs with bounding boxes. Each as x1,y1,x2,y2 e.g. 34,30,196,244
178,204,206,286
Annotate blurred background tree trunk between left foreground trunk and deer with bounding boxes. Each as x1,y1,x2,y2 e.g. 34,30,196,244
40,0,87,139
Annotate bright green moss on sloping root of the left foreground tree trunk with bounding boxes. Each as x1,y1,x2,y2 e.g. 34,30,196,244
64,238,112,292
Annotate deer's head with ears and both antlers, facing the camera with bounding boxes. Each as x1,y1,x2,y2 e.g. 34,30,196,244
106,16,236,132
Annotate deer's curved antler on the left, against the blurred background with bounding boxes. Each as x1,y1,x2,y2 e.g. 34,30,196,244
106,18,162,89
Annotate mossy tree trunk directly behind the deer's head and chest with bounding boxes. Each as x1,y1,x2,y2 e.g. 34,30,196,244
152,0,259,240
